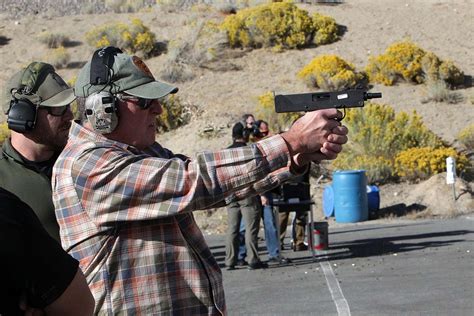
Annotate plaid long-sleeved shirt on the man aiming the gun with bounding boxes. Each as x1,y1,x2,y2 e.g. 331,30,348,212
52,123,293,315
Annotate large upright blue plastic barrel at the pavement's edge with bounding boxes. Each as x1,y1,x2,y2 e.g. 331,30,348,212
332,170,369,223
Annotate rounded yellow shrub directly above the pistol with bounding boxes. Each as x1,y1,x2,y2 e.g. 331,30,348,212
298,55,364,91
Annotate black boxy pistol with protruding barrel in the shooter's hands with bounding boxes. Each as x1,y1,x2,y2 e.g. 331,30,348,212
275,89,382,120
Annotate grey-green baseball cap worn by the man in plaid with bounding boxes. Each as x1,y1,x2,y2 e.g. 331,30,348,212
75,49,178,99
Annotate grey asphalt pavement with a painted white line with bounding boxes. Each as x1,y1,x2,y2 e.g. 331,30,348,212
206,215,474,316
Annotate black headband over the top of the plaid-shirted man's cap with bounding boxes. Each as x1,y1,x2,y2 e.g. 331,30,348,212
90,46,122,85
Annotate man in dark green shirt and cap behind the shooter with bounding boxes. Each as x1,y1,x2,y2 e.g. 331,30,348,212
0,62,75,241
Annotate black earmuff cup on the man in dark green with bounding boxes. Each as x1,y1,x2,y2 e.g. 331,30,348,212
7,99,37,133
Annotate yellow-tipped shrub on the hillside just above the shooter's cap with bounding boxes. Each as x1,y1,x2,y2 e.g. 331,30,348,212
86,18,156,57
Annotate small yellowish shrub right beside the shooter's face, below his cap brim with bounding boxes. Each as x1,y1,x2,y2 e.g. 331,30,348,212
156,95,198,132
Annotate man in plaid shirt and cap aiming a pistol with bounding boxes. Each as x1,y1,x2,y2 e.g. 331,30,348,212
52,47,347,315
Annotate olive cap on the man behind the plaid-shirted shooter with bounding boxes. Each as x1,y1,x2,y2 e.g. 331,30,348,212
3,62,76,113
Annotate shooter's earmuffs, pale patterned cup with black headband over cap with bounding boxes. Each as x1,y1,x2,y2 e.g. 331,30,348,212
86,46,122,134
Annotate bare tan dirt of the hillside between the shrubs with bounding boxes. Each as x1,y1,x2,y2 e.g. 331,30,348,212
0,0,474,233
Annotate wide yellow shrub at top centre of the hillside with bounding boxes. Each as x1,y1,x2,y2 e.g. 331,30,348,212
222,2,337,49
